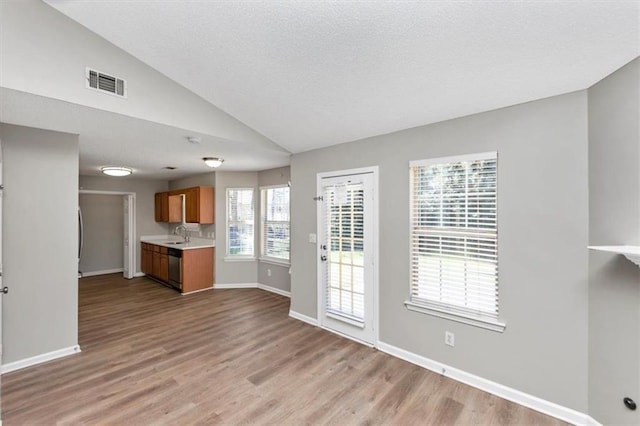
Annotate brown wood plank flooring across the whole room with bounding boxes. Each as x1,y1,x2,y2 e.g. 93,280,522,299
2,274,563,425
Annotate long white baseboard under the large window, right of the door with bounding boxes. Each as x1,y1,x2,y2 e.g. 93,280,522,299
376,341,599,425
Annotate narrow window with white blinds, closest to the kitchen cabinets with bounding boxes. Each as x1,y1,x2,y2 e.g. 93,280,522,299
227,188,255,257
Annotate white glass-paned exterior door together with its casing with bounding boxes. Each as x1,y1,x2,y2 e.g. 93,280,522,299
317,167,378,345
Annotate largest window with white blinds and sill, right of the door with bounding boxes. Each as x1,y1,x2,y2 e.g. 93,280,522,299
406,152,504,331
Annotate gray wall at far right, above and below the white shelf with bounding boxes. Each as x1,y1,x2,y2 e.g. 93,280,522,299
589,59,640,424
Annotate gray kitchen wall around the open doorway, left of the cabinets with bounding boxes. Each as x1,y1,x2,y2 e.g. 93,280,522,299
80,176,169,272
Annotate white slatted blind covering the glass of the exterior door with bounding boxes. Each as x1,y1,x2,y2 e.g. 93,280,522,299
323,183,365,326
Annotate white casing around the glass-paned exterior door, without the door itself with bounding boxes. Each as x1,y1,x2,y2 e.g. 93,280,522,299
316,166,380,347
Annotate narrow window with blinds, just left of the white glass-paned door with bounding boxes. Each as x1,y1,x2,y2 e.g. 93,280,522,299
260,186,289,262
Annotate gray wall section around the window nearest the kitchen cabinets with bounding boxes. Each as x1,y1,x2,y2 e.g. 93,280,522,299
215,171,258,284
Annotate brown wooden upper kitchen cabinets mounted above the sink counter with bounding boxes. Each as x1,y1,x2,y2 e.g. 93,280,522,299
155,186,215,224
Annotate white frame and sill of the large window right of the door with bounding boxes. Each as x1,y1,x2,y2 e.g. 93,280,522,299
405,152,506,332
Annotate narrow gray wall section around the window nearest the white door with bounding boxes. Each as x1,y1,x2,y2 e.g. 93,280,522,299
256,167,291,291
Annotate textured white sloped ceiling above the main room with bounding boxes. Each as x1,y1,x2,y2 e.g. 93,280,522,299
47,0,640,152
